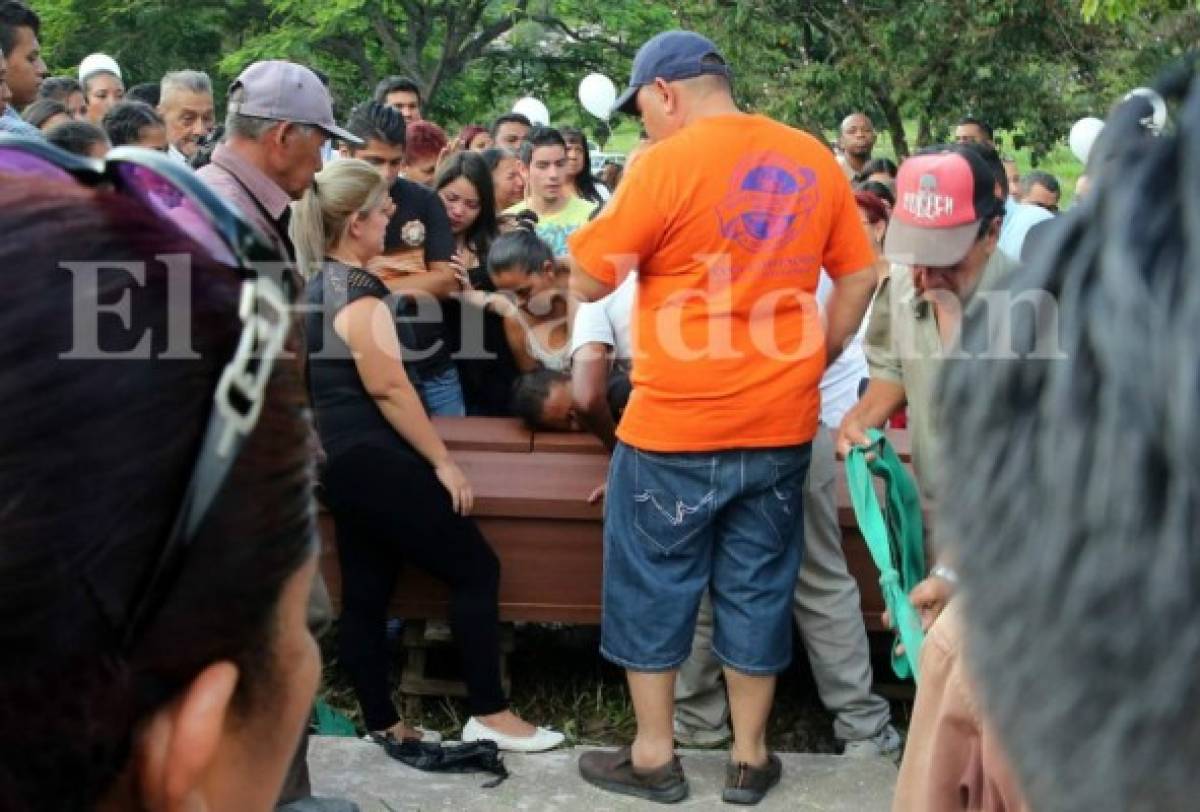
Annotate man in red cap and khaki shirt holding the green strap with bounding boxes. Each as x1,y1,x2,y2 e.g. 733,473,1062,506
838,145,1016,611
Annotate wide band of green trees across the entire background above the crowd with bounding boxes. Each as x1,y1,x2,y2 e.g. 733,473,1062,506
31,0,1200,156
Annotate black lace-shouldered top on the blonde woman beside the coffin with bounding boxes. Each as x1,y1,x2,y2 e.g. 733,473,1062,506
305,260,416,458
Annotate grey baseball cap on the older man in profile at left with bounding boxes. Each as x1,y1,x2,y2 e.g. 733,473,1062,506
229,60,362,146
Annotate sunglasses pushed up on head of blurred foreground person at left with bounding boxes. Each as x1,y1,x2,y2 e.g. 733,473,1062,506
0,136,293,652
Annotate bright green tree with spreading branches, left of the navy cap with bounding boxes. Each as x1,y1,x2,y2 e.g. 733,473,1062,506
221,0,671,125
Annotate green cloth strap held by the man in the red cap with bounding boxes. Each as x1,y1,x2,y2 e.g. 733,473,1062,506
846,428,925,680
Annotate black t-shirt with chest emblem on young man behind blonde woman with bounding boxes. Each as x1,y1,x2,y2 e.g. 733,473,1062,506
384,178,455,377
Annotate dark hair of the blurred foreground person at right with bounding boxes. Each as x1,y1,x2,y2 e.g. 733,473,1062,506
941,58,1200,812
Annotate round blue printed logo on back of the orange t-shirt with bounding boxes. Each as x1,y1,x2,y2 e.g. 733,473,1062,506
716,152,821,253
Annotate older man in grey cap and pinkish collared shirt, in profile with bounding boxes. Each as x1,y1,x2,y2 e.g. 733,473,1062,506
197,61,362,259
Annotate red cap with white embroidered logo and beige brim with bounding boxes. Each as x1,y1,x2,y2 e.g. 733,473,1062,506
883,148,1003,267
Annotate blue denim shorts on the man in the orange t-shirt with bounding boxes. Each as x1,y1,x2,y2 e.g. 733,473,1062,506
600,443,811,675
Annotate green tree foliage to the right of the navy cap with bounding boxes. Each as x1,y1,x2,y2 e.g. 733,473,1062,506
676,0,1142,156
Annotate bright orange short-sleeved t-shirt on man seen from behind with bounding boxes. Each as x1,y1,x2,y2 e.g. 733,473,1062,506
569,114,875,452
